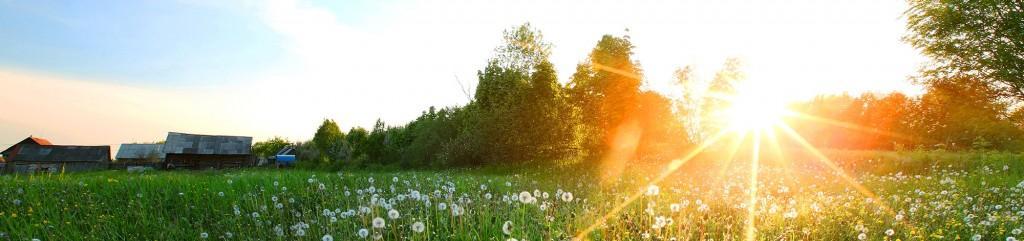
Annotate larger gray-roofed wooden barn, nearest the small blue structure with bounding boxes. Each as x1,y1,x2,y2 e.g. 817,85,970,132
164,132,255,169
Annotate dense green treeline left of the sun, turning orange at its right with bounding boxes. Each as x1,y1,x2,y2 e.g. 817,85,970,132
280,24,691,168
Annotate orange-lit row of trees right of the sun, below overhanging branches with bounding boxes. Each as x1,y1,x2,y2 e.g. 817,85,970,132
786,78,1024,151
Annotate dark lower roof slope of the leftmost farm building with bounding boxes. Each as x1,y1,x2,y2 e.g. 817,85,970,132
10,146,111,162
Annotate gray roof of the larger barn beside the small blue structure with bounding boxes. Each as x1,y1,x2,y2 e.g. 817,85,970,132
164,132,253,155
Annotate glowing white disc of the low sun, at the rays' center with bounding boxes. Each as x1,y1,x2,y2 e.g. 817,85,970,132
724,88,786,131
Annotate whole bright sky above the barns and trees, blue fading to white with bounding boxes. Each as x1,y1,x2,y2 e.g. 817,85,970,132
0,0,925,149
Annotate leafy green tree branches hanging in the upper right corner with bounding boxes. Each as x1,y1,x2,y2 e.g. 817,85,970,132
904,0,1024,101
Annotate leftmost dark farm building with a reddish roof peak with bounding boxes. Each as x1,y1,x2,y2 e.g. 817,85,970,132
0,136,111,173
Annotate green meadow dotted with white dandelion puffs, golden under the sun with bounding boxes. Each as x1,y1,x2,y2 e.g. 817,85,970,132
0,154,1024,240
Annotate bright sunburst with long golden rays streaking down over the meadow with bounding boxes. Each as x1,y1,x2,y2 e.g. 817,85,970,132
573,79,914,240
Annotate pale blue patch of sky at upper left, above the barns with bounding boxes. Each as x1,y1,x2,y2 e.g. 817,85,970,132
0,0,284,85
